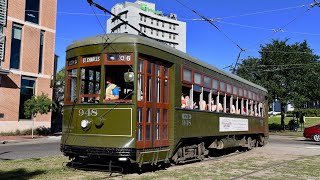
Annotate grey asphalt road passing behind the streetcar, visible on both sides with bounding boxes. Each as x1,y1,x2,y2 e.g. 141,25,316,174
0,135,320,161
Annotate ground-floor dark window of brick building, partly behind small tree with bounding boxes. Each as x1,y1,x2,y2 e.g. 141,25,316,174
19,76,36,119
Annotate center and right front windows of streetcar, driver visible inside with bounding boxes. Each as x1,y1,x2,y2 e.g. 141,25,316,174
80,65,133,103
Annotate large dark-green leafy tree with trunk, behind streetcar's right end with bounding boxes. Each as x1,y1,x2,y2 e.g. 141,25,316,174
235,39,320,128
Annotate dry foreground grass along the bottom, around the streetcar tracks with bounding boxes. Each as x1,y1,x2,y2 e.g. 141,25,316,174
0,156,320,180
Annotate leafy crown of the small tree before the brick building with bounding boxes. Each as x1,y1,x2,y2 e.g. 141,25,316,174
24,93,55,118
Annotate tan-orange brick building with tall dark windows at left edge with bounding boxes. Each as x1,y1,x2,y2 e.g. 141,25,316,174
0,0,57,132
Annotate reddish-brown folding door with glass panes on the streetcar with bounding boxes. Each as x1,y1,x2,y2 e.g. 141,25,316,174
137,59,170,148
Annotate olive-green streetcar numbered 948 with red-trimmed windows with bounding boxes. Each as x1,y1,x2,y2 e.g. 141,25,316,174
61,34,268,170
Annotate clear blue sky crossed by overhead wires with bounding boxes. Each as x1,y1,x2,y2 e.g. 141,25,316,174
55,0,320,70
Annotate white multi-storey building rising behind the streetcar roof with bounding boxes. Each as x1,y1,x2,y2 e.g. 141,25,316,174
107,0,186,52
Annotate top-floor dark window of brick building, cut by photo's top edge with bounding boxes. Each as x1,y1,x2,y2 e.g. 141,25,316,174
25,0,40,24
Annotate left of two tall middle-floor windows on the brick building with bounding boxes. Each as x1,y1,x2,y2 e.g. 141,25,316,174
10,23,22,69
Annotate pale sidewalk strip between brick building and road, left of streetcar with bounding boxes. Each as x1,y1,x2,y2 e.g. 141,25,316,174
0,135,60,144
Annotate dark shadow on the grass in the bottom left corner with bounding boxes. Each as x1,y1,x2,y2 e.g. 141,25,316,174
0,168,46,180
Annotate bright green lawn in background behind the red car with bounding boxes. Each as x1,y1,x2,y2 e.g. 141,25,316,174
269,116,320,136
